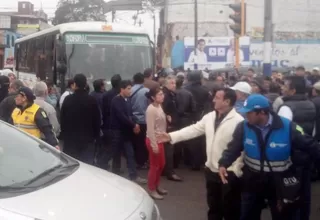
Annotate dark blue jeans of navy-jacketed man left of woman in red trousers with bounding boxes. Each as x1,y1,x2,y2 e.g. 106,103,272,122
107,130,138,180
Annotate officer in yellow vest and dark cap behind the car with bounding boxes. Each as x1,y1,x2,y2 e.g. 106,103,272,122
11,87,59,149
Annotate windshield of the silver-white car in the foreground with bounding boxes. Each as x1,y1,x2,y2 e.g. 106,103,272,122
0,122,79,193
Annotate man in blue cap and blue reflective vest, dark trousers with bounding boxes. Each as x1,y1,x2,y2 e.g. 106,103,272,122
219,94,320,220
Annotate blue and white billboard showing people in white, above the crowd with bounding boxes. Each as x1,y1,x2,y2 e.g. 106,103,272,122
184,37,250,70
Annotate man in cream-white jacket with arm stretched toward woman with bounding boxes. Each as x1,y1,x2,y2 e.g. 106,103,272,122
158,88,244,220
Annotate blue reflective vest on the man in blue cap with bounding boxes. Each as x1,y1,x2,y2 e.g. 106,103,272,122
243,118,292,172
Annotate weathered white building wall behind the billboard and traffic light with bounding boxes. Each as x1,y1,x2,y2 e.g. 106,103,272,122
158,0,320,68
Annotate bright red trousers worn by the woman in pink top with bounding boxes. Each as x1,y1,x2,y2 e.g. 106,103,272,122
146,138,166,191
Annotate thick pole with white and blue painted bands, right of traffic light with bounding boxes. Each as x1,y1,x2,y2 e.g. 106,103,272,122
263,0,273,76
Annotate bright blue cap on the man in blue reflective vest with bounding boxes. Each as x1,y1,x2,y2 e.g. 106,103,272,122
239,94,270,113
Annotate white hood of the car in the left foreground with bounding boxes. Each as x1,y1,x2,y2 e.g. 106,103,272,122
0,163,146,220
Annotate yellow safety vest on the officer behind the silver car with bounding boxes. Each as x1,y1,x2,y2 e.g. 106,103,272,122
11,104,41,138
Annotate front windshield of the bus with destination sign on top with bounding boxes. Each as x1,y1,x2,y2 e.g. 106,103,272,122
65,33,152,82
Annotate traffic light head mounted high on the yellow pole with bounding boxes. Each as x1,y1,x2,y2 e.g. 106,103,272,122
229,0,247,36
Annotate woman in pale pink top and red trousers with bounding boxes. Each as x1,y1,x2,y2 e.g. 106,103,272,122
146,88,168,200
